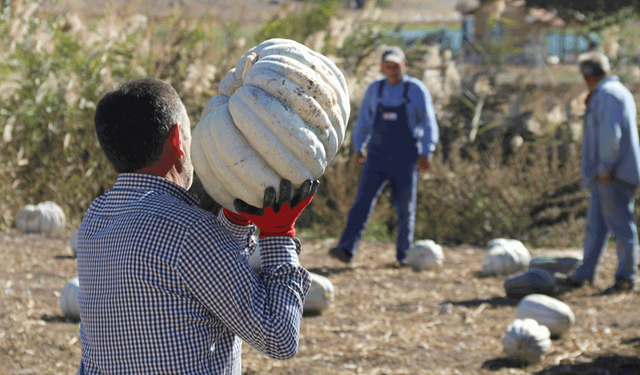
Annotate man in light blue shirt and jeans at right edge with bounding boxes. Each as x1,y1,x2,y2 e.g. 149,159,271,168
566,52,640,294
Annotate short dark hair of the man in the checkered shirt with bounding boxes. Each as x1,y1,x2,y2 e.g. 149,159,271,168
94,78,188,173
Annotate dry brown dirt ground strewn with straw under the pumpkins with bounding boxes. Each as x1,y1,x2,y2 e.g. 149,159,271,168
0,230,640,375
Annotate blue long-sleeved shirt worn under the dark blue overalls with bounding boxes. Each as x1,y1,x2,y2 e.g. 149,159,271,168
353,75,440,155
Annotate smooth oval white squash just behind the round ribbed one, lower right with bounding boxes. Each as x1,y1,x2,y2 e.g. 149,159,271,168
517,294,575,336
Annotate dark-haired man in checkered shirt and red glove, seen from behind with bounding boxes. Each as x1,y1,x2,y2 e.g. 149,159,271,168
77,78,317,375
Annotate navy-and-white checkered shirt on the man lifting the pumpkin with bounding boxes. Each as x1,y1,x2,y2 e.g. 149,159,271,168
77,173,310,374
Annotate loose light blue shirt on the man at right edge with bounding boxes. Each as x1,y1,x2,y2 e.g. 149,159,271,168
581,76,640,187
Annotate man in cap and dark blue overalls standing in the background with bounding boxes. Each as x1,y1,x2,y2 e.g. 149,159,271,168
329,47,439,265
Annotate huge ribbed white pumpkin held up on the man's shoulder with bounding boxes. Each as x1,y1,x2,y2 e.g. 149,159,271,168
191,39,350,211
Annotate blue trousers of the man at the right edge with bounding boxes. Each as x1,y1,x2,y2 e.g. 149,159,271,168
571,180,638,282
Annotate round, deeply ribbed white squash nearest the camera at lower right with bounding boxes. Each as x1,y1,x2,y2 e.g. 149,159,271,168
502,319,551,363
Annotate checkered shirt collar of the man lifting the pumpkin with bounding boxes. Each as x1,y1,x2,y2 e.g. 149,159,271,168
113,173,200,206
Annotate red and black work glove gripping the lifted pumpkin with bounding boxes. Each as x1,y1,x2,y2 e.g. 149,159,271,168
233,180,320,238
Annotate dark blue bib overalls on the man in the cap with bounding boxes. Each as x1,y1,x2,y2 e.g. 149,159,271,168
337,80,421,261
